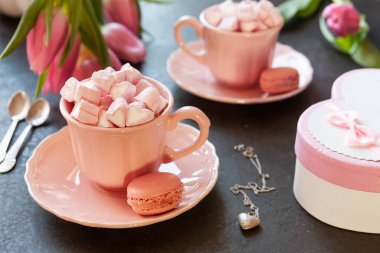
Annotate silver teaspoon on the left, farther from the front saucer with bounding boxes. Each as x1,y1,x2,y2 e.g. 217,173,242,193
0,91,30,162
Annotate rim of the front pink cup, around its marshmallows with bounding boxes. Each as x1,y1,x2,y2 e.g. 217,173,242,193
59,76,174,134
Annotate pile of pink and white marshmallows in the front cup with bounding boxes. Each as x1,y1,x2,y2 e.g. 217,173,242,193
60,63,168,128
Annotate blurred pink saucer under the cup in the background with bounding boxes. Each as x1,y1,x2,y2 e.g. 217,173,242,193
167,40,313,104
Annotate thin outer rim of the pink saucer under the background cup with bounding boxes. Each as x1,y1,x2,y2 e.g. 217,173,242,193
166,40,314,105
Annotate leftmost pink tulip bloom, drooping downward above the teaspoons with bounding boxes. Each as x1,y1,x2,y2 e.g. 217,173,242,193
26,10,69,75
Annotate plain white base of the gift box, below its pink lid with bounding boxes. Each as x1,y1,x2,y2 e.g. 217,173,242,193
293,159,380,233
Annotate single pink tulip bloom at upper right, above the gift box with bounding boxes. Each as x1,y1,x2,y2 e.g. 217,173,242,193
322,3,360,36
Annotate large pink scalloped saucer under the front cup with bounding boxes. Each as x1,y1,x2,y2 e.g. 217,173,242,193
25,124,219,228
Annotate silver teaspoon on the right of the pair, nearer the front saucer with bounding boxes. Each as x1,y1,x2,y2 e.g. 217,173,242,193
0,98,50,173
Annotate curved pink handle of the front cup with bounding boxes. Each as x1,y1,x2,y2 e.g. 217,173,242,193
163,106,210,163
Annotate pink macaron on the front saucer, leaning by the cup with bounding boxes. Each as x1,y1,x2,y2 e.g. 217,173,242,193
127,172,183,215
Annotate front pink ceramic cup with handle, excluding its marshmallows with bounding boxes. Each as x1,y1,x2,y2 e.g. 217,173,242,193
60,77,210,191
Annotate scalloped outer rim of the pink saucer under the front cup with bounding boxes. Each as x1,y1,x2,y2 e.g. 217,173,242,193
24,123,220,229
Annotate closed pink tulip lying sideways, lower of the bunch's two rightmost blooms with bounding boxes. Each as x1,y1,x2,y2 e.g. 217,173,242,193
102,23,146,63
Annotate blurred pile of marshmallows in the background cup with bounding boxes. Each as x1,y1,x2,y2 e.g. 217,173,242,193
204,0,284,32
